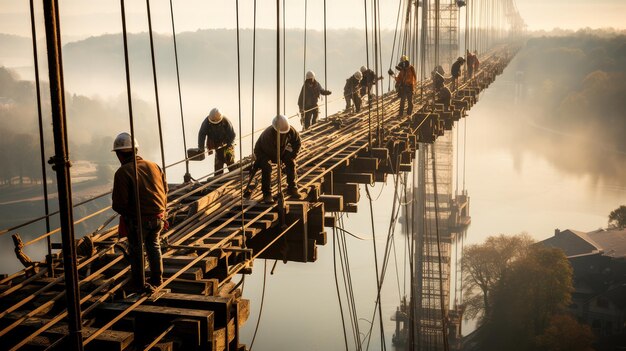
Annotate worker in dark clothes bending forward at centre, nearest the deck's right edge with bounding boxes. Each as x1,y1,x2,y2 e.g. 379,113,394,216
246,115,301,204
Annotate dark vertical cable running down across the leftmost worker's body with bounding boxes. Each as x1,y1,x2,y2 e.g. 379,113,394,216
120,0,146,284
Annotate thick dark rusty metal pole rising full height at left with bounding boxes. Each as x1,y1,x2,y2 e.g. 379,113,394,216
43,0,83,350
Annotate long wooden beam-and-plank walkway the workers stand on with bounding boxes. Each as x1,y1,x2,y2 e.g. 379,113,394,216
0,47,509,350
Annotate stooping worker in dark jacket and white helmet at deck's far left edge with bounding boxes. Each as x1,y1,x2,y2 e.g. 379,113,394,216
198,107,235,175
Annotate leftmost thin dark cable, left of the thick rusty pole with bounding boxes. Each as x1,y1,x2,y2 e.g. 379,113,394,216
30,0,54,277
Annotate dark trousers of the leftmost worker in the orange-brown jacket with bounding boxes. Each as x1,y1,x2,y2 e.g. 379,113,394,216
126,216,163,288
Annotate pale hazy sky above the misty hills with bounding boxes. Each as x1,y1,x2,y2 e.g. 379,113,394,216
0,0,626,37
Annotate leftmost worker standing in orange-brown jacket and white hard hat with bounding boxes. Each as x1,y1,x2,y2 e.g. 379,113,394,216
112,133,167,290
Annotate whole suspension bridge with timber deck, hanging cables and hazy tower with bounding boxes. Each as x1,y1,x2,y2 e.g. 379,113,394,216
0,0,523,350
